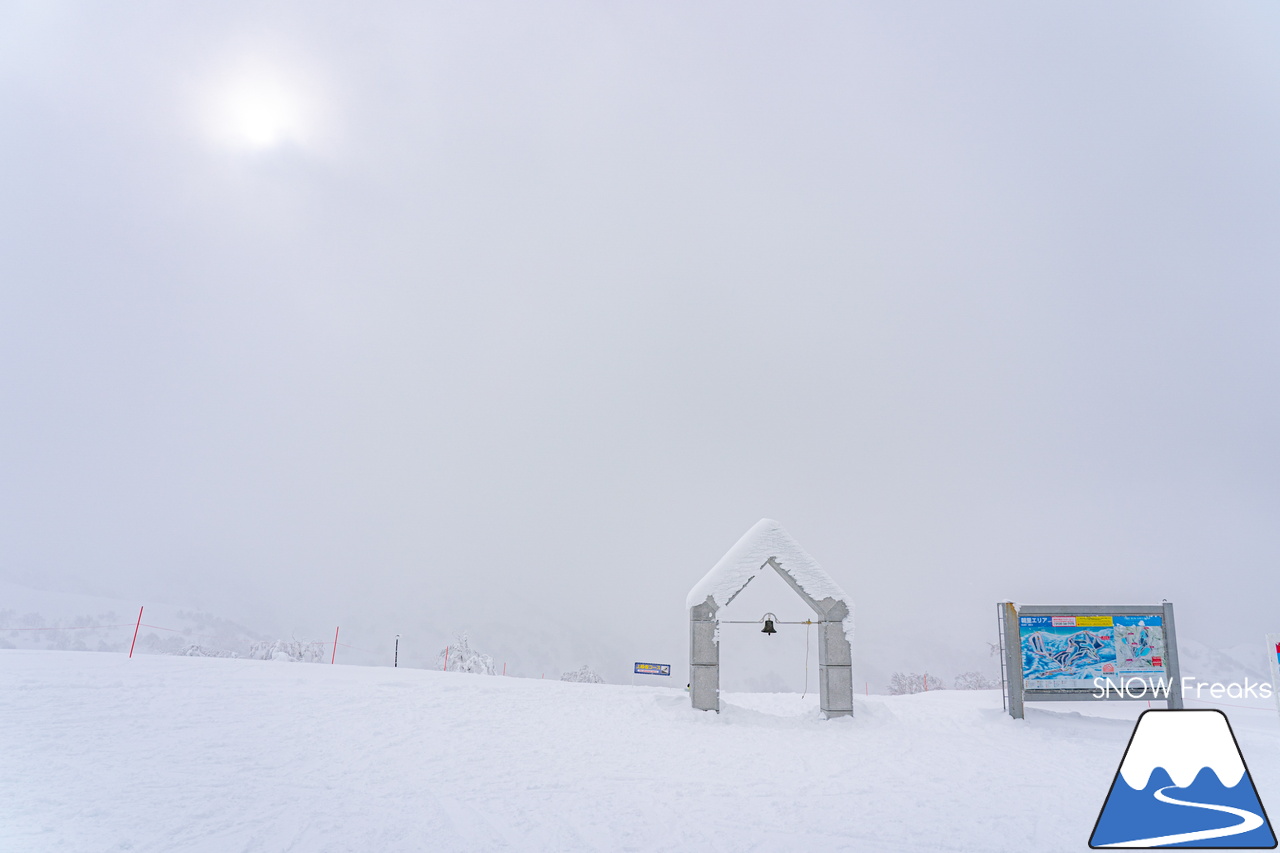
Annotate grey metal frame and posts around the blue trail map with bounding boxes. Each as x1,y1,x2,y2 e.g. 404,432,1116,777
996,601,1183,720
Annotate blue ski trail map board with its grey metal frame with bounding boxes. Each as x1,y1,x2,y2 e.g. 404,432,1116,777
997,602,1183,719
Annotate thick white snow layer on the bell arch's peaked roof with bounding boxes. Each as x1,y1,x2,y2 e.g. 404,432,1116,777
685,519,852,614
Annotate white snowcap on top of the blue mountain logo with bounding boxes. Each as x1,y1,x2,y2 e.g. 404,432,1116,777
1120,711,1244,790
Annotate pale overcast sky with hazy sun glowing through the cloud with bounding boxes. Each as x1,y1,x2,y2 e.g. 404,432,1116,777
0,1,1280,686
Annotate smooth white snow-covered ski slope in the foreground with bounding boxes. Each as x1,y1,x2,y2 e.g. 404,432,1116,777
0,649,1280,853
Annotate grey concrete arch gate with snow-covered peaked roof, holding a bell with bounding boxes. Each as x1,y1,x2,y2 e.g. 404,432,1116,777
686,519,854,717
